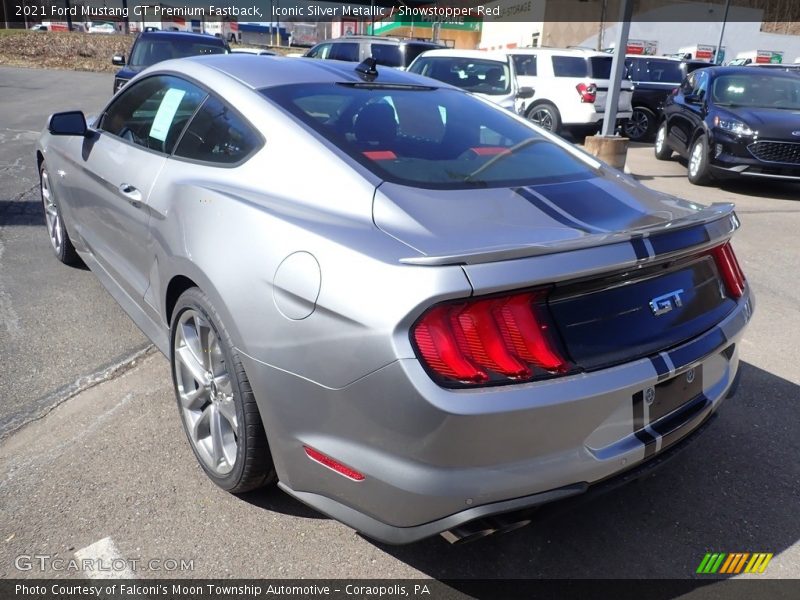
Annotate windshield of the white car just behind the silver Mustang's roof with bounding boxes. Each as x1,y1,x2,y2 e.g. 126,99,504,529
409,56,511,96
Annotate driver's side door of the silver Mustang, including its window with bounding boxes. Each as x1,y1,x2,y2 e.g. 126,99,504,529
73,75,206,302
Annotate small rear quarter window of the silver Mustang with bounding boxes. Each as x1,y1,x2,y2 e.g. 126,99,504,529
175,96,261,164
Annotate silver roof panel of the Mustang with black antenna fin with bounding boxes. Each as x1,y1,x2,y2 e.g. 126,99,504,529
174,54,453,89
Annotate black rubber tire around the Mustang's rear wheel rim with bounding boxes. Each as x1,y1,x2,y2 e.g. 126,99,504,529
170,288,277,494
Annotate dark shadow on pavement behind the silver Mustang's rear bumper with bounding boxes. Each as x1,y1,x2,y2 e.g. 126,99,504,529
360,363,800,579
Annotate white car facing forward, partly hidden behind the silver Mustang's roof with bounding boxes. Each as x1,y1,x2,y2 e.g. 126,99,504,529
408,49,534,112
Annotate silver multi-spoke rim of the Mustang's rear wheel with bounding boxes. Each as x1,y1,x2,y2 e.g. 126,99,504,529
173,309,239,475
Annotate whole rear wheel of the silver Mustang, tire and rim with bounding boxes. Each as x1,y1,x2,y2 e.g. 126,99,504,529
171,288,275,493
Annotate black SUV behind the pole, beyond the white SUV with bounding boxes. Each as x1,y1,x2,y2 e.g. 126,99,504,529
624,56,711,142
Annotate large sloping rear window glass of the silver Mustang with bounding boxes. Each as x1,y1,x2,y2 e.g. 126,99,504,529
261,83,593,189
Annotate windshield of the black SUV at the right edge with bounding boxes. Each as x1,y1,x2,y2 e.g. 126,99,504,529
712,72,800,110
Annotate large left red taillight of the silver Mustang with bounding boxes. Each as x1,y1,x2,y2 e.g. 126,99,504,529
412,291,568,384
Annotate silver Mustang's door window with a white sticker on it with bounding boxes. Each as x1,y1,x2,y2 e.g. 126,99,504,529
100,75,206,154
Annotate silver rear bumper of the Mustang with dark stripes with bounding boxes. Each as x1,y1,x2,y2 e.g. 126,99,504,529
238,290,752,544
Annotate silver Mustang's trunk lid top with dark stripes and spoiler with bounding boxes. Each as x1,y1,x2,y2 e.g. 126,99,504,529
373,169,732,264
